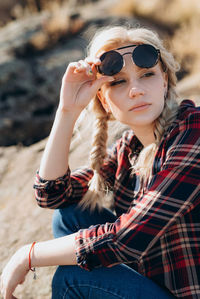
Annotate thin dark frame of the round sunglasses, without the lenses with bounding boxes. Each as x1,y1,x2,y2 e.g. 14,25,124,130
97,44,161,76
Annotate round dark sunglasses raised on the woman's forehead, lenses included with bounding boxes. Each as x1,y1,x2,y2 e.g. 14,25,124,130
97,44,160,76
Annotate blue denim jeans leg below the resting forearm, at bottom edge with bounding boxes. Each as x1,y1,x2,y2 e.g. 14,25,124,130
52,264,171,299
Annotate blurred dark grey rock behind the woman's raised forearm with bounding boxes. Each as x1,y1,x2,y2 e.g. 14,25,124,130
0,4,152,146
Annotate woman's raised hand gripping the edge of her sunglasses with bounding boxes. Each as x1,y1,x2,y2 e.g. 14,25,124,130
59,57,113,113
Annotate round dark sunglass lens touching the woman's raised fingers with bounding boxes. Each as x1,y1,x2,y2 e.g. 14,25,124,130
98,51,123,76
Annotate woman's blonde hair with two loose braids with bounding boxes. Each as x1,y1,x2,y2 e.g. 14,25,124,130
81,26,179,209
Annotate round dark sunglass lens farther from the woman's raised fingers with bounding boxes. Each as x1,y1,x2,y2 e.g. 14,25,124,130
133,44,158,68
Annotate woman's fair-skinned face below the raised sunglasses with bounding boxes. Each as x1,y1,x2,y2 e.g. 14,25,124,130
98,46,167,130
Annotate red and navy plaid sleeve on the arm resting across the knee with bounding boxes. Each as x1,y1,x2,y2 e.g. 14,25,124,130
76,113,200,270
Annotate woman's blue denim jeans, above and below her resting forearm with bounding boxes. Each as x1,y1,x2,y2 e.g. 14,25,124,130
52,205,172,299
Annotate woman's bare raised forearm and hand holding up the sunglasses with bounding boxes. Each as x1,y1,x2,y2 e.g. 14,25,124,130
38,58,113,180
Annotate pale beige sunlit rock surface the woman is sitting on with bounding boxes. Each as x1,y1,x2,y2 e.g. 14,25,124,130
0,105,128,299
